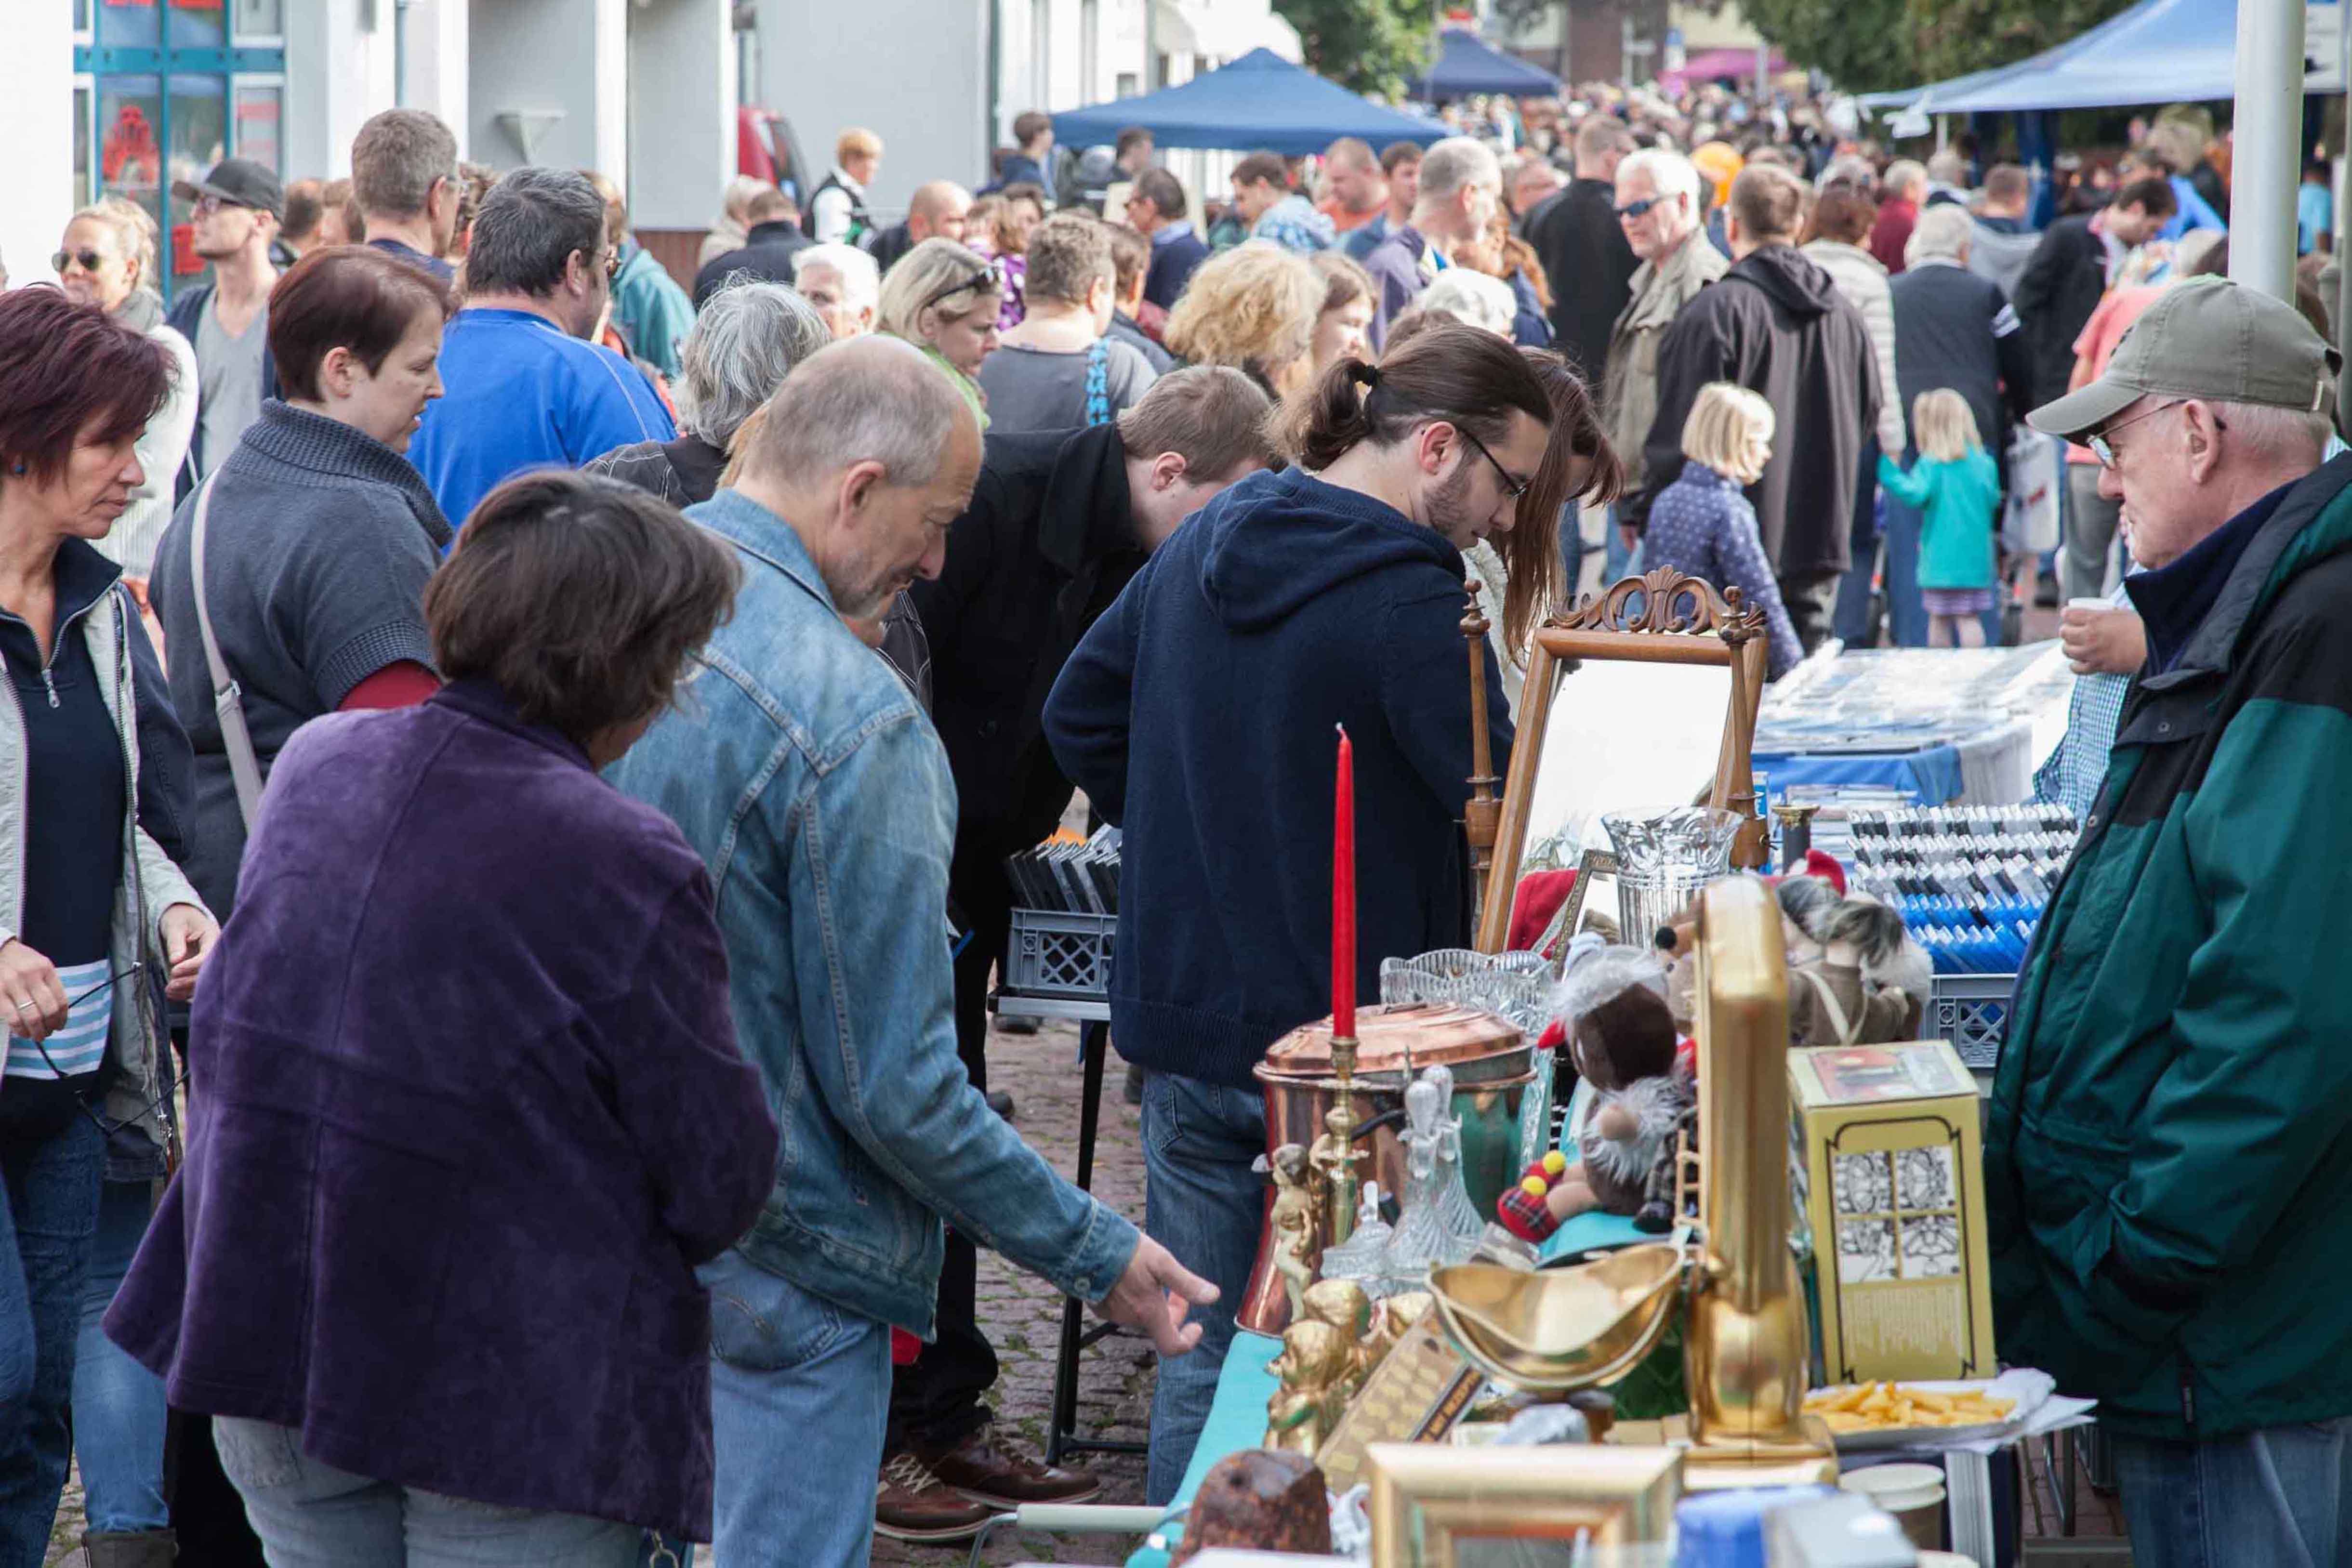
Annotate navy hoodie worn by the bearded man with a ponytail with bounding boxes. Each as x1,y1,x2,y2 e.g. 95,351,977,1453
1044,470,1510,1088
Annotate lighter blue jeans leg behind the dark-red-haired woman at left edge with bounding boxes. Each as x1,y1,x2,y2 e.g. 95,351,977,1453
73,1180,172,1535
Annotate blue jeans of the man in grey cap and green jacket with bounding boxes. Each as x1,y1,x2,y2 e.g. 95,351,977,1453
2112,1418,2352,1568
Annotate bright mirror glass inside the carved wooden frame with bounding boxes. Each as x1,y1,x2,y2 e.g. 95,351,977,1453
1520,658,1731,870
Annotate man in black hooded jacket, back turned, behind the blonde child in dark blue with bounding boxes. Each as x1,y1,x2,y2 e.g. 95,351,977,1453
1623,165,1889,654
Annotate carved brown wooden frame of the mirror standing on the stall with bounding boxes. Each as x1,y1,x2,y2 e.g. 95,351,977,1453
1477,567,1766,952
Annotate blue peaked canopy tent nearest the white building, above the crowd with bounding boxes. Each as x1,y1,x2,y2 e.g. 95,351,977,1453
1054,49,1451,158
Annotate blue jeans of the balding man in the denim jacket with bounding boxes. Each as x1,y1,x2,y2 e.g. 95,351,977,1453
701,1251,891,1568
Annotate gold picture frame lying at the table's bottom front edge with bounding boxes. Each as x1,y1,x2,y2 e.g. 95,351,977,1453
1366,1443,1682,1568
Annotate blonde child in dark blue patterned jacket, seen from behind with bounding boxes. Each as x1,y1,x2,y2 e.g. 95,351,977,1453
1639,381,1804,679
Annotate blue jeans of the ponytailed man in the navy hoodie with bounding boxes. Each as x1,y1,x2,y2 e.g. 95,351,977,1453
1143,1072,1268,1504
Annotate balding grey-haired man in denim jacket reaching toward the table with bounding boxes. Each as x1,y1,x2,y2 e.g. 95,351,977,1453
611,339,1216,1568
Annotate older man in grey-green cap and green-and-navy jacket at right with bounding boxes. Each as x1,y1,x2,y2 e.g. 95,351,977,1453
1985,280,2352,1568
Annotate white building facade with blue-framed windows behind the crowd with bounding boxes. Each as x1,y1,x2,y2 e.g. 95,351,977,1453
13,0,1298,303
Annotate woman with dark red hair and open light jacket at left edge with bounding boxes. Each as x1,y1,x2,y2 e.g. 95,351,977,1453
0,288,216,1563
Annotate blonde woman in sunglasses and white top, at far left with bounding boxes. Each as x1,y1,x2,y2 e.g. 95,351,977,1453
50,195,198,606
